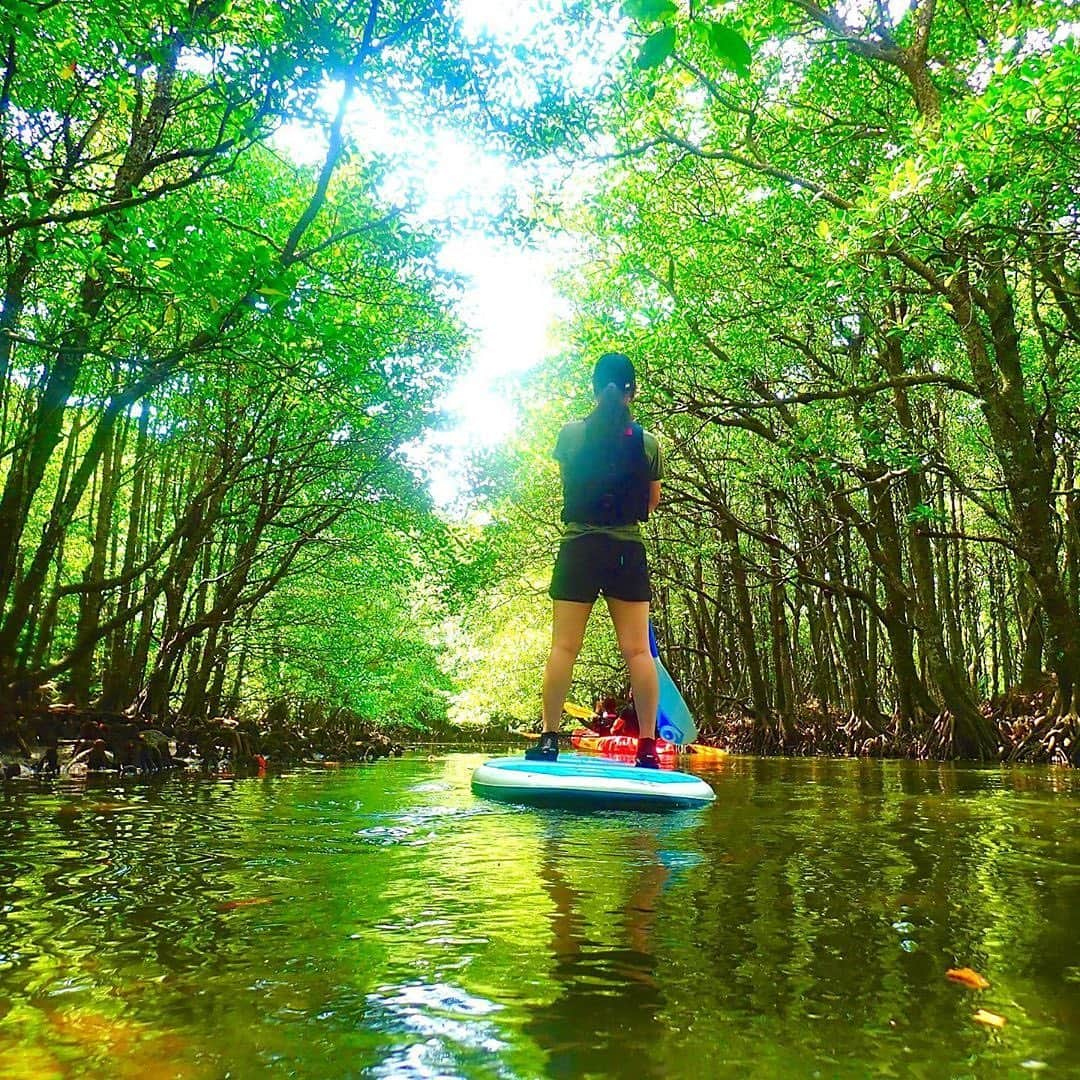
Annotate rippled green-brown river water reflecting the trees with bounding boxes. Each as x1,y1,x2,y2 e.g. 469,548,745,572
0,754,1080,1080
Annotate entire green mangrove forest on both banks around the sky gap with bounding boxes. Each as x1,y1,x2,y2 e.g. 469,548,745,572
0,0,1080,759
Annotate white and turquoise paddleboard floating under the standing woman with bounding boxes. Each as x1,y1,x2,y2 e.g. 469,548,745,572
472,754,716,810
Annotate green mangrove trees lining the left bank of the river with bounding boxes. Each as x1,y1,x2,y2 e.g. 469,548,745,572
0,0,591,724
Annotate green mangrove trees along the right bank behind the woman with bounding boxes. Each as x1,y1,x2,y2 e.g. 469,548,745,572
457,0,1080,758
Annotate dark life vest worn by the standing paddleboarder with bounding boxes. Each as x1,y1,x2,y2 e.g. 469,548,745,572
562,423,650,526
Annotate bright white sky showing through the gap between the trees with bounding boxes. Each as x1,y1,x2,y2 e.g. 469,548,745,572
275,0,595,508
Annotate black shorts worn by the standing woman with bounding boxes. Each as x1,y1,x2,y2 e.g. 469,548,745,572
548,532,652,604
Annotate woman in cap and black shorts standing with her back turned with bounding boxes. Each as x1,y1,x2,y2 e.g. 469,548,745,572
525,352,663,769
